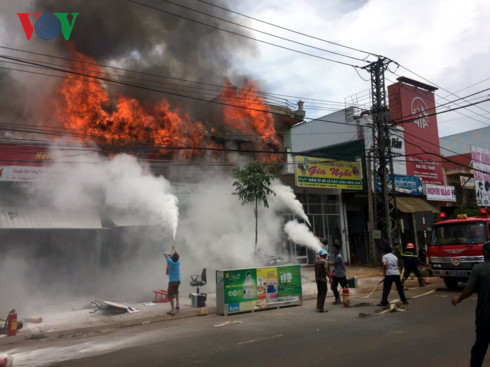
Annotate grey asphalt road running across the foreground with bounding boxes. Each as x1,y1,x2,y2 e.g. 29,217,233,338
3,287,482,367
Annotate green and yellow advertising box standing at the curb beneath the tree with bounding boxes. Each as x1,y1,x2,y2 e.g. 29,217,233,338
216,265,302,315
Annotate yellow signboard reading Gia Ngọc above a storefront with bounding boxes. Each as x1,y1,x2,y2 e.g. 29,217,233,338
295,156,362,190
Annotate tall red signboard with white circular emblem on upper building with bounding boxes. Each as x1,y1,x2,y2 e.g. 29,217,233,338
388,77,444,185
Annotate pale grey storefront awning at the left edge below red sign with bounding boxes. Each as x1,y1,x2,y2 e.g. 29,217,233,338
0,206,102,229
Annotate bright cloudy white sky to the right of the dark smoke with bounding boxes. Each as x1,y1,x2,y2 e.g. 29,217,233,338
233,0,490,136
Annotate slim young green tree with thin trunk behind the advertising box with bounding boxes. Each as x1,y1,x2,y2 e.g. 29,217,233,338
233,161,279,252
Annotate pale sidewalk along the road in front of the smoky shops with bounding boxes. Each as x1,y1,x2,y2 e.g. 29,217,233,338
0,266,428,346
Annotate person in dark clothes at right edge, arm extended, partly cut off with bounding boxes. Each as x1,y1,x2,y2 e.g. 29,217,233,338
451,242,490,367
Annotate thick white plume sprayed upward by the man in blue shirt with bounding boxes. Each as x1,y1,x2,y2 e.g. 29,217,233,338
36,148,179,238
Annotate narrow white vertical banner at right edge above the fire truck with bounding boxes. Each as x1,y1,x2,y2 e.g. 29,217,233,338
471,147,490,206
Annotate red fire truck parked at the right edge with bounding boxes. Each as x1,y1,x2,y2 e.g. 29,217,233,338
427,209,490,289
